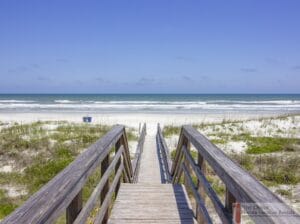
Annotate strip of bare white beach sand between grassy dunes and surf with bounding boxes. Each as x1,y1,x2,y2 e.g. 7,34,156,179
0,113,274,133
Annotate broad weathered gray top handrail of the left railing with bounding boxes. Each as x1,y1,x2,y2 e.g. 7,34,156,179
2,125,125,224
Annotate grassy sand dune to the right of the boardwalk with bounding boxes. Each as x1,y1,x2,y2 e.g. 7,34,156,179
163,115,300,214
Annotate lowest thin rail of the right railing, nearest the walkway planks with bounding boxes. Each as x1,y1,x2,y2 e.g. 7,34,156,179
181,163,212,223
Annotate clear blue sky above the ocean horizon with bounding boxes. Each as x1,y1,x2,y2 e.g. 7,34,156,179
0,0,300,93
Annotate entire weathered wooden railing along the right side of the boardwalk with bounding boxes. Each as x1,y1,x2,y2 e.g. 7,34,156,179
157,126,300,224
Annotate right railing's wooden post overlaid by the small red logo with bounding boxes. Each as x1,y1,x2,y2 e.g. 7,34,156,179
225,188,241,224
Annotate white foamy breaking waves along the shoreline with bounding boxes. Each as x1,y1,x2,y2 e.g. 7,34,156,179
0,100,300,112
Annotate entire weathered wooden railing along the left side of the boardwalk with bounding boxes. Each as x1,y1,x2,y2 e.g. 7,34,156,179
2,125,146,224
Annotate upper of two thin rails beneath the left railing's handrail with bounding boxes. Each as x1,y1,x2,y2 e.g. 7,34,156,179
74,146,124,224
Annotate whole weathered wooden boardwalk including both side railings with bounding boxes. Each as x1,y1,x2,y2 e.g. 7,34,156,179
1,124,300,224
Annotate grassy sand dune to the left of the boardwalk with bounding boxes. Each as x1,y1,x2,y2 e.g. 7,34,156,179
0,122,137,219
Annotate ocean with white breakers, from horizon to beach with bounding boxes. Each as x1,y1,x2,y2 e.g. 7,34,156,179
0,94,300,114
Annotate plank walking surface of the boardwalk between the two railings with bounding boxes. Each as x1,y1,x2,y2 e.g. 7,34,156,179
108,135,196,224
